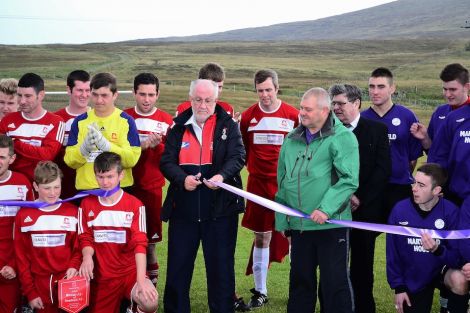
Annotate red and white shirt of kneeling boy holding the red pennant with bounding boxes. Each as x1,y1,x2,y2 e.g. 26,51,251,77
15,203,81,301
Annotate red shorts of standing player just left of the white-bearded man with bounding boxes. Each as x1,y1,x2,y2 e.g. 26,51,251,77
132,187,162,243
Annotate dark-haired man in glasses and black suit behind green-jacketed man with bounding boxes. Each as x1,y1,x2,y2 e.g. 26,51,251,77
329,84,391,313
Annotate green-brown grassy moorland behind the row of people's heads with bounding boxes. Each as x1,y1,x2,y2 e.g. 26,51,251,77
0,39,470,111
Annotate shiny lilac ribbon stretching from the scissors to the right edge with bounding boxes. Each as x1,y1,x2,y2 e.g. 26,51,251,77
210,181,470,239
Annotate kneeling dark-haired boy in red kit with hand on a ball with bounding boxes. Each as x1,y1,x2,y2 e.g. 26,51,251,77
78,152,158,313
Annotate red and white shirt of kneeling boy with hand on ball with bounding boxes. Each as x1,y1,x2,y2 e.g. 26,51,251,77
78,190,147,279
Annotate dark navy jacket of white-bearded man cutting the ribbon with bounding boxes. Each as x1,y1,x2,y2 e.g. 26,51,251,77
160,105,246,221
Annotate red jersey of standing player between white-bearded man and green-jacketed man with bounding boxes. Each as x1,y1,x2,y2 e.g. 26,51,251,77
240,102,299,177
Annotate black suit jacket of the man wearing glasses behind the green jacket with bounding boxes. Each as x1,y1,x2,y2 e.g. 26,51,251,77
353,117,392,223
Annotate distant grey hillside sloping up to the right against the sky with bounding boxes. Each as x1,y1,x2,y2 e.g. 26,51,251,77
132,0,470,43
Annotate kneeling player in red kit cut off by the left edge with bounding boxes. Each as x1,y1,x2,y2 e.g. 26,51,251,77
0,135,34,312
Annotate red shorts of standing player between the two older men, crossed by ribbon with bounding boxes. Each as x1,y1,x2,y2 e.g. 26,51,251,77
242,175,277,232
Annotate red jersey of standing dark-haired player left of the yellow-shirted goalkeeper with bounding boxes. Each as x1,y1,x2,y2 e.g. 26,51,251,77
0,111,64,181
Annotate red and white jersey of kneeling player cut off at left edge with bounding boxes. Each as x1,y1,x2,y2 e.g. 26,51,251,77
0,171,34,271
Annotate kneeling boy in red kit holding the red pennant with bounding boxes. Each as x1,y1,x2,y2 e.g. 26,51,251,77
14,161,81,313
